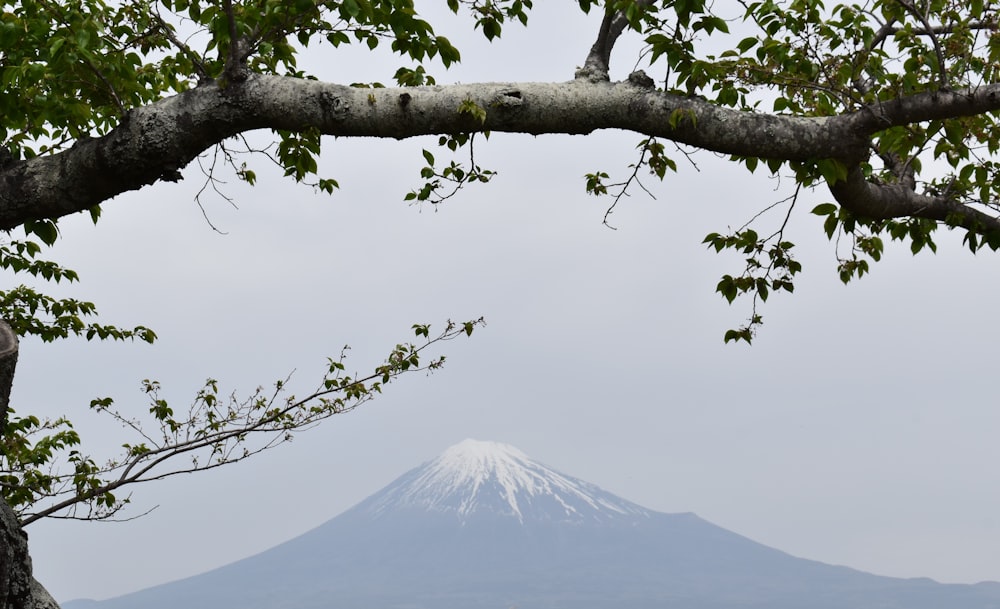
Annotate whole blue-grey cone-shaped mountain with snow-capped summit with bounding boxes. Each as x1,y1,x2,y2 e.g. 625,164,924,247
63,440,1000,609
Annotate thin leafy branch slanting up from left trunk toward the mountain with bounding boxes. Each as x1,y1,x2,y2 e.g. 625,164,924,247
10,318,485,526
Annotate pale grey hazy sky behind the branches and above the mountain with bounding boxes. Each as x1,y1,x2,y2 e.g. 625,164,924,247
14,1,1000,600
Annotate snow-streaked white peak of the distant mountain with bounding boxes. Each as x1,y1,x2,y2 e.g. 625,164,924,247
364,440,649,522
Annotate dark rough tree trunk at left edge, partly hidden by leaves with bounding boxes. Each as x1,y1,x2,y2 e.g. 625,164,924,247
0,321,59,609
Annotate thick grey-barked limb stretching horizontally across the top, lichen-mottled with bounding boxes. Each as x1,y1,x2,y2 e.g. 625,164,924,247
0,76,1000,229
